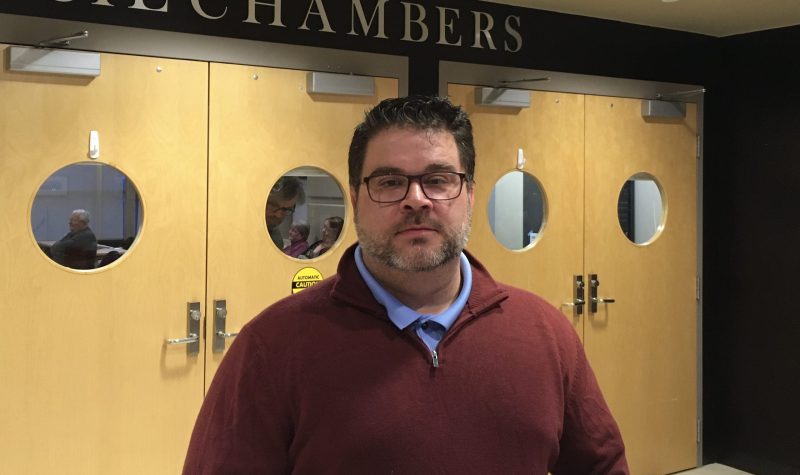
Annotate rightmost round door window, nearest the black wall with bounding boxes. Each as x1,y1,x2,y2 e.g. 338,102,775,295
617,173,665,244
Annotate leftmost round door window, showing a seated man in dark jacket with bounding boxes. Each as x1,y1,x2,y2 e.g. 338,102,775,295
31,163,142,270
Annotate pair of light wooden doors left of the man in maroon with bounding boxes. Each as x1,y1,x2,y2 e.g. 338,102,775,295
0,47,397,474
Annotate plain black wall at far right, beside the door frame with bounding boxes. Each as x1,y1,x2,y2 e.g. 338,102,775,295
703,27,800,475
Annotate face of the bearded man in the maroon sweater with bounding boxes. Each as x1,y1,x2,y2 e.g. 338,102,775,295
350,128,475,271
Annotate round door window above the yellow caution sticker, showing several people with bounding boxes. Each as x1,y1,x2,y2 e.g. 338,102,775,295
264,167,345,259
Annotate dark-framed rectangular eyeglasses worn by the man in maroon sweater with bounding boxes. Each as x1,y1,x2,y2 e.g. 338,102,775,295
364,172,467,203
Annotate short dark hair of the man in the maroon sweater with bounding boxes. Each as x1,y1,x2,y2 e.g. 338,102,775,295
347,96,475,189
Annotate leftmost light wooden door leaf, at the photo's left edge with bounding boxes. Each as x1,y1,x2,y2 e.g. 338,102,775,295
0,48,207,474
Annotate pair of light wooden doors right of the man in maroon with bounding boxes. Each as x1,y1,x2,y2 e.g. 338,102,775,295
448,84,698,475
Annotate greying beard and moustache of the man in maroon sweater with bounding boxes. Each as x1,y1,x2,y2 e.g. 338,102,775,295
355,207,472,272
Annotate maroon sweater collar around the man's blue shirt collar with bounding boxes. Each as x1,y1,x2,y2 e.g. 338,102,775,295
331,244,508,319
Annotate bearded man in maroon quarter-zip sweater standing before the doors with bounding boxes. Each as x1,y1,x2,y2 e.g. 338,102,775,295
184,97,628,475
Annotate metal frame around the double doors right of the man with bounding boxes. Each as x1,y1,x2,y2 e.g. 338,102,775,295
439,61,705,467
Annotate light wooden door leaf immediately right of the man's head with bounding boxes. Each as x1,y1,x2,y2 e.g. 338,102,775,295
448,85,584,337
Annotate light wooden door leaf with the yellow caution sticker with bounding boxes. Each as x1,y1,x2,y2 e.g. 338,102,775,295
206,64,398,384
